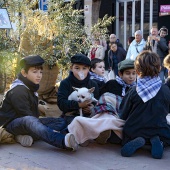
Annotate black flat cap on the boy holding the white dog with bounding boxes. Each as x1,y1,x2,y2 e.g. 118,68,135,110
71,54,91,66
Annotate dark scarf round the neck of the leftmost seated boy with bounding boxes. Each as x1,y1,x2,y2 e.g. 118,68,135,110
18,73,39,92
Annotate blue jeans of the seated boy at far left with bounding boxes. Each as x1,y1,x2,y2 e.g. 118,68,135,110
6,116,66,148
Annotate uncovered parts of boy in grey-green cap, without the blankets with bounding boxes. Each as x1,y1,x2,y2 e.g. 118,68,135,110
96,59,136,144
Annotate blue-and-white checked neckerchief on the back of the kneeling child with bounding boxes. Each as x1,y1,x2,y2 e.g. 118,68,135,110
136,76,162,103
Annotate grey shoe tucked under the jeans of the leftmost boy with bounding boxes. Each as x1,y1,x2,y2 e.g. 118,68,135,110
15,135,33,147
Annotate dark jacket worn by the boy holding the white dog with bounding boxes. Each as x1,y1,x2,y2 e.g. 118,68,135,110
57,72,99,114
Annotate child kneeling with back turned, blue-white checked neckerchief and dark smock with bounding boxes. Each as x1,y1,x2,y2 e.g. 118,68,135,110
119,51,170,159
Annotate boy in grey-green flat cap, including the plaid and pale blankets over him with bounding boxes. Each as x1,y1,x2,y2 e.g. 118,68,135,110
65,60,136,146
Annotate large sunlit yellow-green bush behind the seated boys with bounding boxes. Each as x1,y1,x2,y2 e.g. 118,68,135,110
5,0,114,69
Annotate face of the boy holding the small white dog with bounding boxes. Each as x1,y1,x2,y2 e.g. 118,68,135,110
71,64,90,80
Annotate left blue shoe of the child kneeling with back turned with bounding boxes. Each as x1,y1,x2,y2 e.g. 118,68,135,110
121,137,145,157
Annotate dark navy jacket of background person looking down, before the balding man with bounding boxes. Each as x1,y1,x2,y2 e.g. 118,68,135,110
108,47,126,69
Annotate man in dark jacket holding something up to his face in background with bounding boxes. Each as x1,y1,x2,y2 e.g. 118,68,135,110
144,27,168,82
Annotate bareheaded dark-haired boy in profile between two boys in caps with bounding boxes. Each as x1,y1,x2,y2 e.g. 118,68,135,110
90,58,107,91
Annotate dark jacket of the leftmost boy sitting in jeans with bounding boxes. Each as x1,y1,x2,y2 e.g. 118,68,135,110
0,85,39,126
